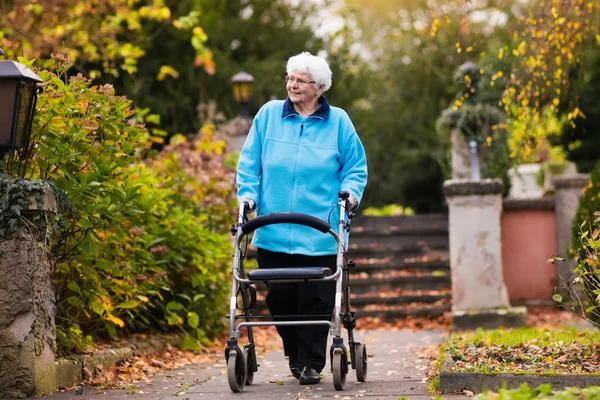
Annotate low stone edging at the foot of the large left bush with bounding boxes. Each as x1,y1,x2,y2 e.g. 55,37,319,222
54,334,181,391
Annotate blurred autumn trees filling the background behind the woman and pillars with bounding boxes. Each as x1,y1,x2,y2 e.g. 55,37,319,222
0,0,600,212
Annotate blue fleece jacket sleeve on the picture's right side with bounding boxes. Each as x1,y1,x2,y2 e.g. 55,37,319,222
340,132,368,208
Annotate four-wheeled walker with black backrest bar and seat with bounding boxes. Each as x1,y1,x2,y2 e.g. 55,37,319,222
225,192,367,393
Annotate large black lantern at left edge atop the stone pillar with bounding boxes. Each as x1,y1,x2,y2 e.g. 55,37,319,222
0,49,42,160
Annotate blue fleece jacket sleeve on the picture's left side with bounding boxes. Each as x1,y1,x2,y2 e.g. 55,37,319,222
236,119,262,206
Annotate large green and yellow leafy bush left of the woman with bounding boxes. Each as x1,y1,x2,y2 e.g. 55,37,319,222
5,58,235,352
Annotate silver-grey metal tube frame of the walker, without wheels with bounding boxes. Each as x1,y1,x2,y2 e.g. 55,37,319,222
229,199,346,339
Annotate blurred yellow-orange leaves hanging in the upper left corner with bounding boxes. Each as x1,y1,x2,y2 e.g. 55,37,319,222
0,0,214,77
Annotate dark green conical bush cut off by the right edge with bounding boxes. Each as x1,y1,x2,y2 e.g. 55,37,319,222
571,163,600,325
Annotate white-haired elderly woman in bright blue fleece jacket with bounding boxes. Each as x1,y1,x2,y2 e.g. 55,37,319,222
237,52,367,384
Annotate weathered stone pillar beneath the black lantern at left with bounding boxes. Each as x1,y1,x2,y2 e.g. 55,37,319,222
0,180,59,399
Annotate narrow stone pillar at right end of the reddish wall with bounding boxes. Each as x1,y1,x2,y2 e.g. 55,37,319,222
552,174,590,295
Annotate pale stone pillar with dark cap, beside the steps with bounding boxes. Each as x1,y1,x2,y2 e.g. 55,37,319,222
444,179,526,329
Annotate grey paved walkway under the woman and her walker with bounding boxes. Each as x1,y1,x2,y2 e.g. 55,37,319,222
44,330,465,400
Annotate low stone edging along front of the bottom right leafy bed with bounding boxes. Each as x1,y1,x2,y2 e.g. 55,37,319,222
439,353,600,394
